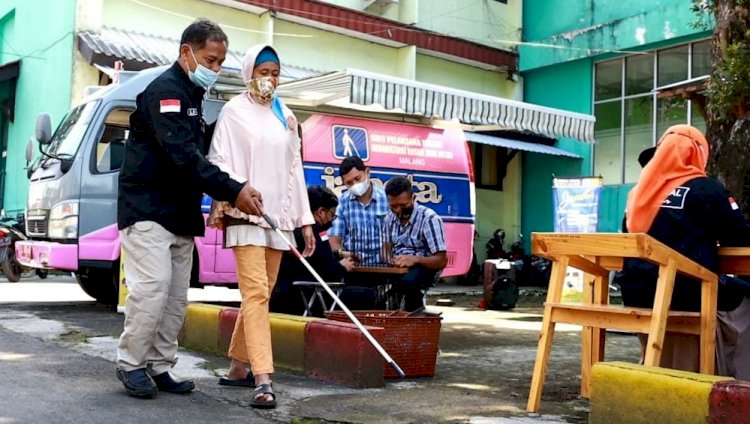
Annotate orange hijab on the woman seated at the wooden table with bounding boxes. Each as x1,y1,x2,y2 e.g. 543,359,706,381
625,124,708,233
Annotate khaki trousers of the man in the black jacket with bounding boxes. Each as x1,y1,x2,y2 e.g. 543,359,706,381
117,221,194,375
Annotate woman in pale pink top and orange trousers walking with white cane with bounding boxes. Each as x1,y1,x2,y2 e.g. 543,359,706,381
208,44,315,408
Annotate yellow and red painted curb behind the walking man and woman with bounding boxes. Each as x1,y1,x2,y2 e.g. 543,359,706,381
178,303,385,387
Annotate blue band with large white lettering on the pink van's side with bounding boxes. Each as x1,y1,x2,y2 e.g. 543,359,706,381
305,164,474,223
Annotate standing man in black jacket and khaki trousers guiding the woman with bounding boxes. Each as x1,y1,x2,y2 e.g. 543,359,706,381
117,19,262,398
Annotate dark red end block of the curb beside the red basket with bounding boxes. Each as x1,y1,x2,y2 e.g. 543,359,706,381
305,320,385,388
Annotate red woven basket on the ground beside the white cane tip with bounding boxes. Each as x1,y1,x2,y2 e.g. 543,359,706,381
326,311,443,378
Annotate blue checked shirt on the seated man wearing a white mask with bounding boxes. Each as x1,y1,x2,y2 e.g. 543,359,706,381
328,184,390,265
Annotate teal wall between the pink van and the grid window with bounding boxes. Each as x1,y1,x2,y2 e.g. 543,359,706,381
521,59,593,240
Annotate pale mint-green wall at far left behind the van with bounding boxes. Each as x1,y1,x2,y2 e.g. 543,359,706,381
0,0,76,213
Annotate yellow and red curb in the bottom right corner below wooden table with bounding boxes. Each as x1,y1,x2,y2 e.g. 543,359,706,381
589,362,750,424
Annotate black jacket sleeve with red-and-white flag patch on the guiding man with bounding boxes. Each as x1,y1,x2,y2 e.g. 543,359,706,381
143,86,243,202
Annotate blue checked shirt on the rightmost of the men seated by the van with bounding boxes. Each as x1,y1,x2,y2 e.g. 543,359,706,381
385,203,446,257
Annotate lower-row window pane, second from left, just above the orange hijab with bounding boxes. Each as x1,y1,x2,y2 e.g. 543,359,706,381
625,96,654,183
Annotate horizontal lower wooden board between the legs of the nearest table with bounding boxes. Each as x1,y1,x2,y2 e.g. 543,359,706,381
550,303,701,336
